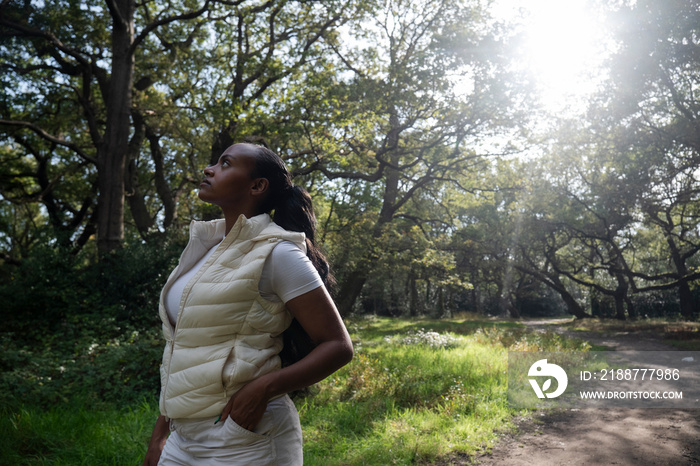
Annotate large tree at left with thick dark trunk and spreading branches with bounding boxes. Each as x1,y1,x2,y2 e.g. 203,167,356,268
0,0,354,252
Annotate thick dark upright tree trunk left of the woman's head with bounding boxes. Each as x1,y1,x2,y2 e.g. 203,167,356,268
97,0,134,254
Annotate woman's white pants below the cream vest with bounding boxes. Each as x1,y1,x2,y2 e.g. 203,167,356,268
158,395,303,466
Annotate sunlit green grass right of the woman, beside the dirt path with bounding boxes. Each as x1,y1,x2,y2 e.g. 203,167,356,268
299,316,581,465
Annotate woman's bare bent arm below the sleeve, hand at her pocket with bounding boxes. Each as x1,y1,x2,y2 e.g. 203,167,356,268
221,286,353,430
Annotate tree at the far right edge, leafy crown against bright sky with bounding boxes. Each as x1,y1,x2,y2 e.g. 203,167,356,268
596,0,700,318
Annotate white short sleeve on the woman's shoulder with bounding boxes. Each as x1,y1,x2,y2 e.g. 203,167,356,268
259,241,323,303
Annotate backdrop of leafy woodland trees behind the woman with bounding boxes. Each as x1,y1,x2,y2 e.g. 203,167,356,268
0,0,700,323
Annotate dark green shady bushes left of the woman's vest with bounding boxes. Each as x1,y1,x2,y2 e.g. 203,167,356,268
0,238,180,407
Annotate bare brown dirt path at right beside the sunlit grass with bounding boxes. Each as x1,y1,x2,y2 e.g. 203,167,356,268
472,322,700,466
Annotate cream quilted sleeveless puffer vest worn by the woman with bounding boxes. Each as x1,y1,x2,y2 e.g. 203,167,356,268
159,214,306,419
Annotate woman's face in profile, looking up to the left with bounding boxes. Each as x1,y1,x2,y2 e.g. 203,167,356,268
199,144,259,208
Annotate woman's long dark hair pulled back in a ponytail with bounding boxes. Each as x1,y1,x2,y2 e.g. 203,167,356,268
251,145,335,376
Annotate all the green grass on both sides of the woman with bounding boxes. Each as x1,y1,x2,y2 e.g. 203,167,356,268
0,316,585,466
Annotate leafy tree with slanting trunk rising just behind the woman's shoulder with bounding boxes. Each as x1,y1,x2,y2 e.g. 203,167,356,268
282,1,528,314
